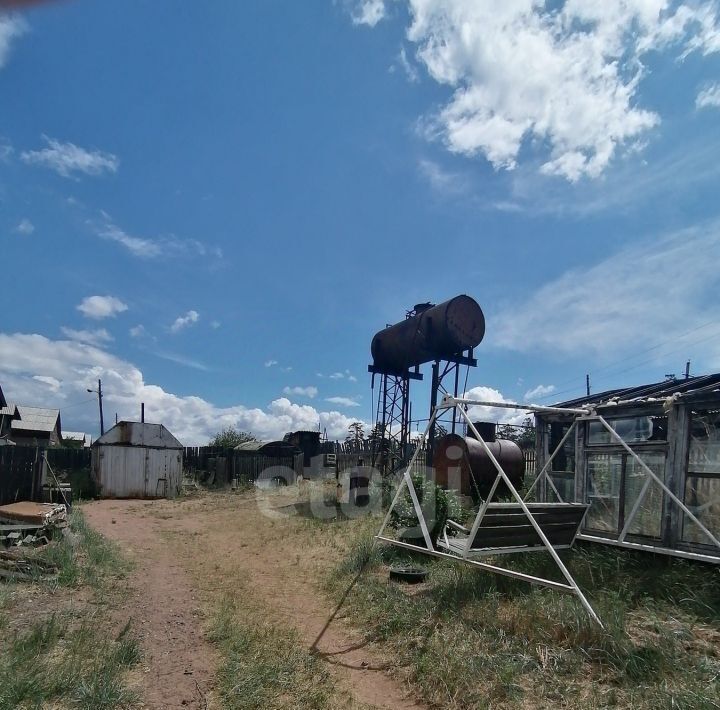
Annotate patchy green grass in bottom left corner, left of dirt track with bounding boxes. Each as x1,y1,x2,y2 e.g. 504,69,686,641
0,509,140,710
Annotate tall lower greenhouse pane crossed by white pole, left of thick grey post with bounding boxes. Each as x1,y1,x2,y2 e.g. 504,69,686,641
623,452,665,538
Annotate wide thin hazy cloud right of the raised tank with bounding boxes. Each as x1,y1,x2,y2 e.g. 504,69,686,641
486,221,720,367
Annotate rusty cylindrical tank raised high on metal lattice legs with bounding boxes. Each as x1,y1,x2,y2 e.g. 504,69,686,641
370,296,485,375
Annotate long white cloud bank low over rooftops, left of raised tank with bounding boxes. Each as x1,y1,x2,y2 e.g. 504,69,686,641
0,333,368,446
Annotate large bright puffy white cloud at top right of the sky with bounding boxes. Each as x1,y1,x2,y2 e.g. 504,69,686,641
368,0,720,181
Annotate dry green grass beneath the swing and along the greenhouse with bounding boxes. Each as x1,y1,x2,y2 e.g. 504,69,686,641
328,526,720,708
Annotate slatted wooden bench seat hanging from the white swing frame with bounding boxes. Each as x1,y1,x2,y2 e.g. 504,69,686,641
438,503,590,556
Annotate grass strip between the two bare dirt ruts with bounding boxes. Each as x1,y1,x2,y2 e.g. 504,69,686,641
210,599,338,710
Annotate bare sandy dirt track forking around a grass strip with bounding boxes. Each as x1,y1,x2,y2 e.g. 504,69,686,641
84,493,423,710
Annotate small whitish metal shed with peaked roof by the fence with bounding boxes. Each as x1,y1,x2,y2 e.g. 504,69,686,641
92,422,183,498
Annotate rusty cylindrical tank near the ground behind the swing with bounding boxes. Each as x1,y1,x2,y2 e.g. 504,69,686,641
433,431,525,500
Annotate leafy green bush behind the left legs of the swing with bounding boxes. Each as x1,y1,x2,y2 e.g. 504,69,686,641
390,473,468,544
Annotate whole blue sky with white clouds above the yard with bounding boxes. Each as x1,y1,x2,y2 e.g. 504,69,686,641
0,0,720,444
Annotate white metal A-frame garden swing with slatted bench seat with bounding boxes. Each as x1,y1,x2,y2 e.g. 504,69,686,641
375,396,602,627
